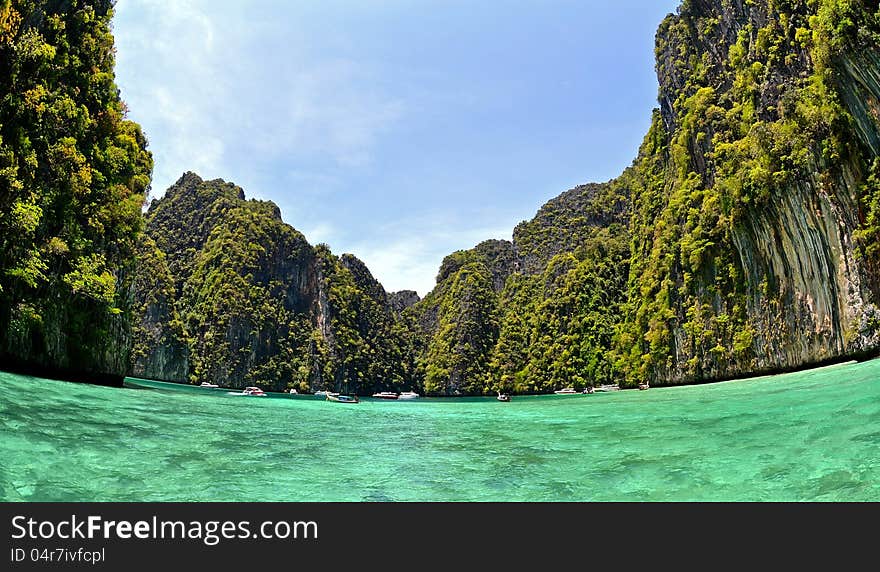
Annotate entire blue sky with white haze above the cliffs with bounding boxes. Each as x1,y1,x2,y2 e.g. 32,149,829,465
114,0,679,295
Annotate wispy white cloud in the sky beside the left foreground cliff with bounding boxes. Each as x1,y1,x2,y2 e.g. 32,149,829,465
115,0,406,195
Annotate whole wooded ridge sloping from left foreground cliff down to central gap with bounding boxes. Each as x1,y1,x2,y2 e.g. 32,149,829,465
131,173,418,392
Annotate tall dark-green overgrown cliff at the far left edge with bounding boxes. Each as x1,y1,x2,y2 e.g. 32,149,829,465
0,0,152,376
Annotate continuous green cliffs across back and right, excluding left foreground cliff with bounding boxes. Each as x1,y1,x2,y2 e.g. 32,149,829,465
129,0,880,395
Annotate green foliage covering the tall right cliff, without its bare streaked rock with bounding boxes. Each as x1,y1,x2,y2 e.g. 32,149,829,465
617,0,877,385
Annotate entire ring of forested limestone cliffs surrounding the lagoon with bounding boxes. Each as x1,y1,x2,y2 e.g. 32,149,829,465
0,0,880,395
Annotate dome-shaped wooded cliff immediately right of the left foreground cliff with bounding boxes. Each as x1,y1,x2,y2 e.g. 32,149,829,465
131,173,317,388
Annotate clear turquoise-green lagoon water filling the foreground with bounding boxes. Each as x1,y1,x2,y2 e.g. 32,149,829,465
0,361,880,501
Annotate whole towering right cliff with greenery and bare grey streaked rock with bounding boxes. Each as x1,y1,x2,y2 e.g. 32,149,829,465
628,0,880,384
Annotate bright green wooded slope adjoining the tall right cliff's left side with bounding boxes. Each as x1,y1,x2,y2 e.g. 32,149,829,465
490,225,629,393
